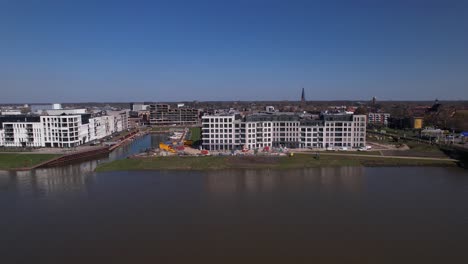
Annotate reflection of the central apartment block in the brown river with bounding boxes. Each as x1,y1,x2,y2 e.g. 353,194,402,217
205,167,365,196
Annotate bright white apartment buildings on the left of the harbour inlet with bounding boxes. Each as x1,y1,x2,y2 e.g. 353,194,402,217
0,110,128,148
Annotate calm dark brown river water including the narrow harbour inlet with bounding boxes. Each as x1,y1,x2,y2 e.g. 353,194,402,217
0,136,468,263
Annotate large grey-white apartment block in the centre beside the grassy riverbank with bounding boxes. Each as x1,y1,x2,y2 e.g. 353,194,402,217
202,113,366,150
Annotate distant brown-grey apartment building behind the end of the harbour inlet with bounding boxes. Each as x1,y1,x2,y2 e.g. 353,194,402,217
149,104,199,125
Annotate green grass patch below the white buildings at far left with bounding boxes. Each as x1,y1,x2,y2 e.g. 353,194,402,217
0,153,61,170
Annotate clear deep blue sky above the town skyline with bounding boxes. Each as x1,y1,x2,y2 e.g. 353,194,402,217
0,0,468,103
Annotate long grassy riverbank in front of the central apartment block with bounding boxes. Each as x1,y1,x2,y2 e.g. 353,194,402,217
96,154,457,172
